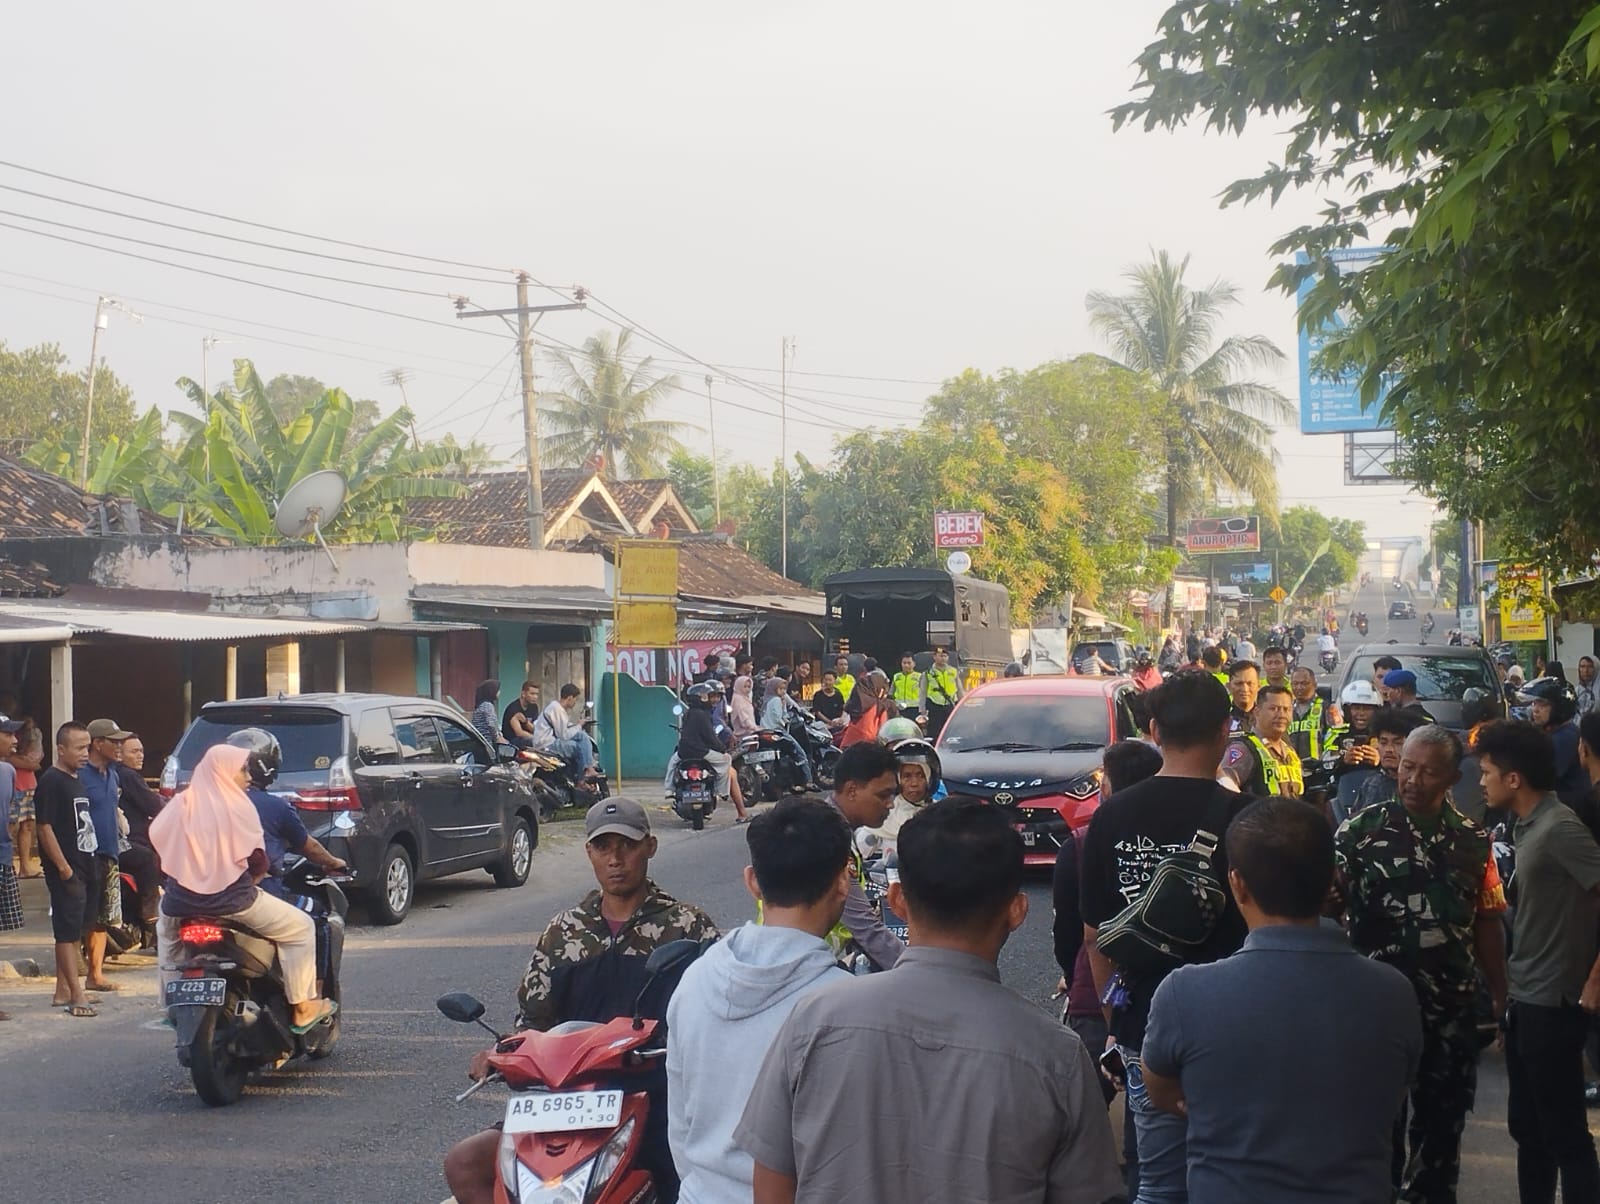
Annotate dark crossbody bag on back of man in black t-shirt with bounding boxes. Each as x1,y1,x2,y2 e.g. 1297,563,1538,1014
1098,805,1227,975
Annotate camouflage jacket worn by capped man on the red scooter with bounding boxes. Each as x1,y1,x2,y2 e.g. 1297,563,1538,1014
517,882,720,1029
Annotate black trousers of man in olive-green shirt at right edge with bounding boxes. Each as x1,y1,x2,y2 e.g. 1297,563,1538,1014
1506,1002,1600,1204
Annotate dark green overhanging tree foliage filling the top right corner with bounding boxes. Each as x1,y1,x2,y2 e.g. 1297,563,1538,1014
1115,0,1600,572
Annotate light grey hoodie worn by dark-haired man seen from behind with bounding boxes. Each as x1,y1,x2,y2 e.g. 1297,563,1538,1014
667,924,850,1204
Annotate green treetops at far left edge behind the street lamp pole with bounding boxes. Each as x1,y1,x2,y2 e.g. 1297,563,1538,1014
0,341,134,454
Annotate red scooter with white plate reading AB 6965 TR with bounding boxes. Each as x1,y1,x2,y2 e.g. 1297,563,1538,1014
438,940,701,1204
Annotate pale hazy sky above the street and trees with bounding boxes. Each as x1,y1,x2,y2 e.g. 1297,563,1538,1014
0,0,1429,535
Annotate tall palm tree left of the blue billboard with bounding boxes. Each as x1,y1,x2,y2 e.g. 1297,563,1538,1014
1088,251,1294,624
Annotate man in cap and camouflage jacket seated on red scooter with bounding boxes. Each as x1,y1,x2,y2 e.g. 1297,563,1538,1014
445,796,720,1204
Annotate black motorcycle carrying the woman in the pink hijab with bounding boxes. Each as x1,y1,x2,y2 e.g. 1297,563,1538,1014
163,860,352,1108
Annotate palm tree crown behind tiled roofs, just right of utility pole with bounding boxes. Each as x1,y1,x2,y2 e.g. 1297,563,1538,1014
539,330,683,477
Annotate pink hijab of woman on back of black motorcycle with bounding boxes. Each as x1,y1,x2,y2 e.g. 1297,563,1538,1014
150,744,266,895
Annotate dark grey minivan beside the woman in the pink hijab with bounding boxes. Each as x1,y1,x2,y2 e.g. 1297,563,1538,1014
162,693,539,924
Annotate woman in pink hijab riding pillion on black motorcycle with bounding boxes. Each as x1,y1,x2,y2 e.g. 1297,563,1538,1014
150,744,339,1033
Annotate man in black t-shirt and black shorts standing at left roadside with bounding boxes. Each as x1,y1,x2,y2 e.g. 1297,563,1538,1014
34,724,102,1017
